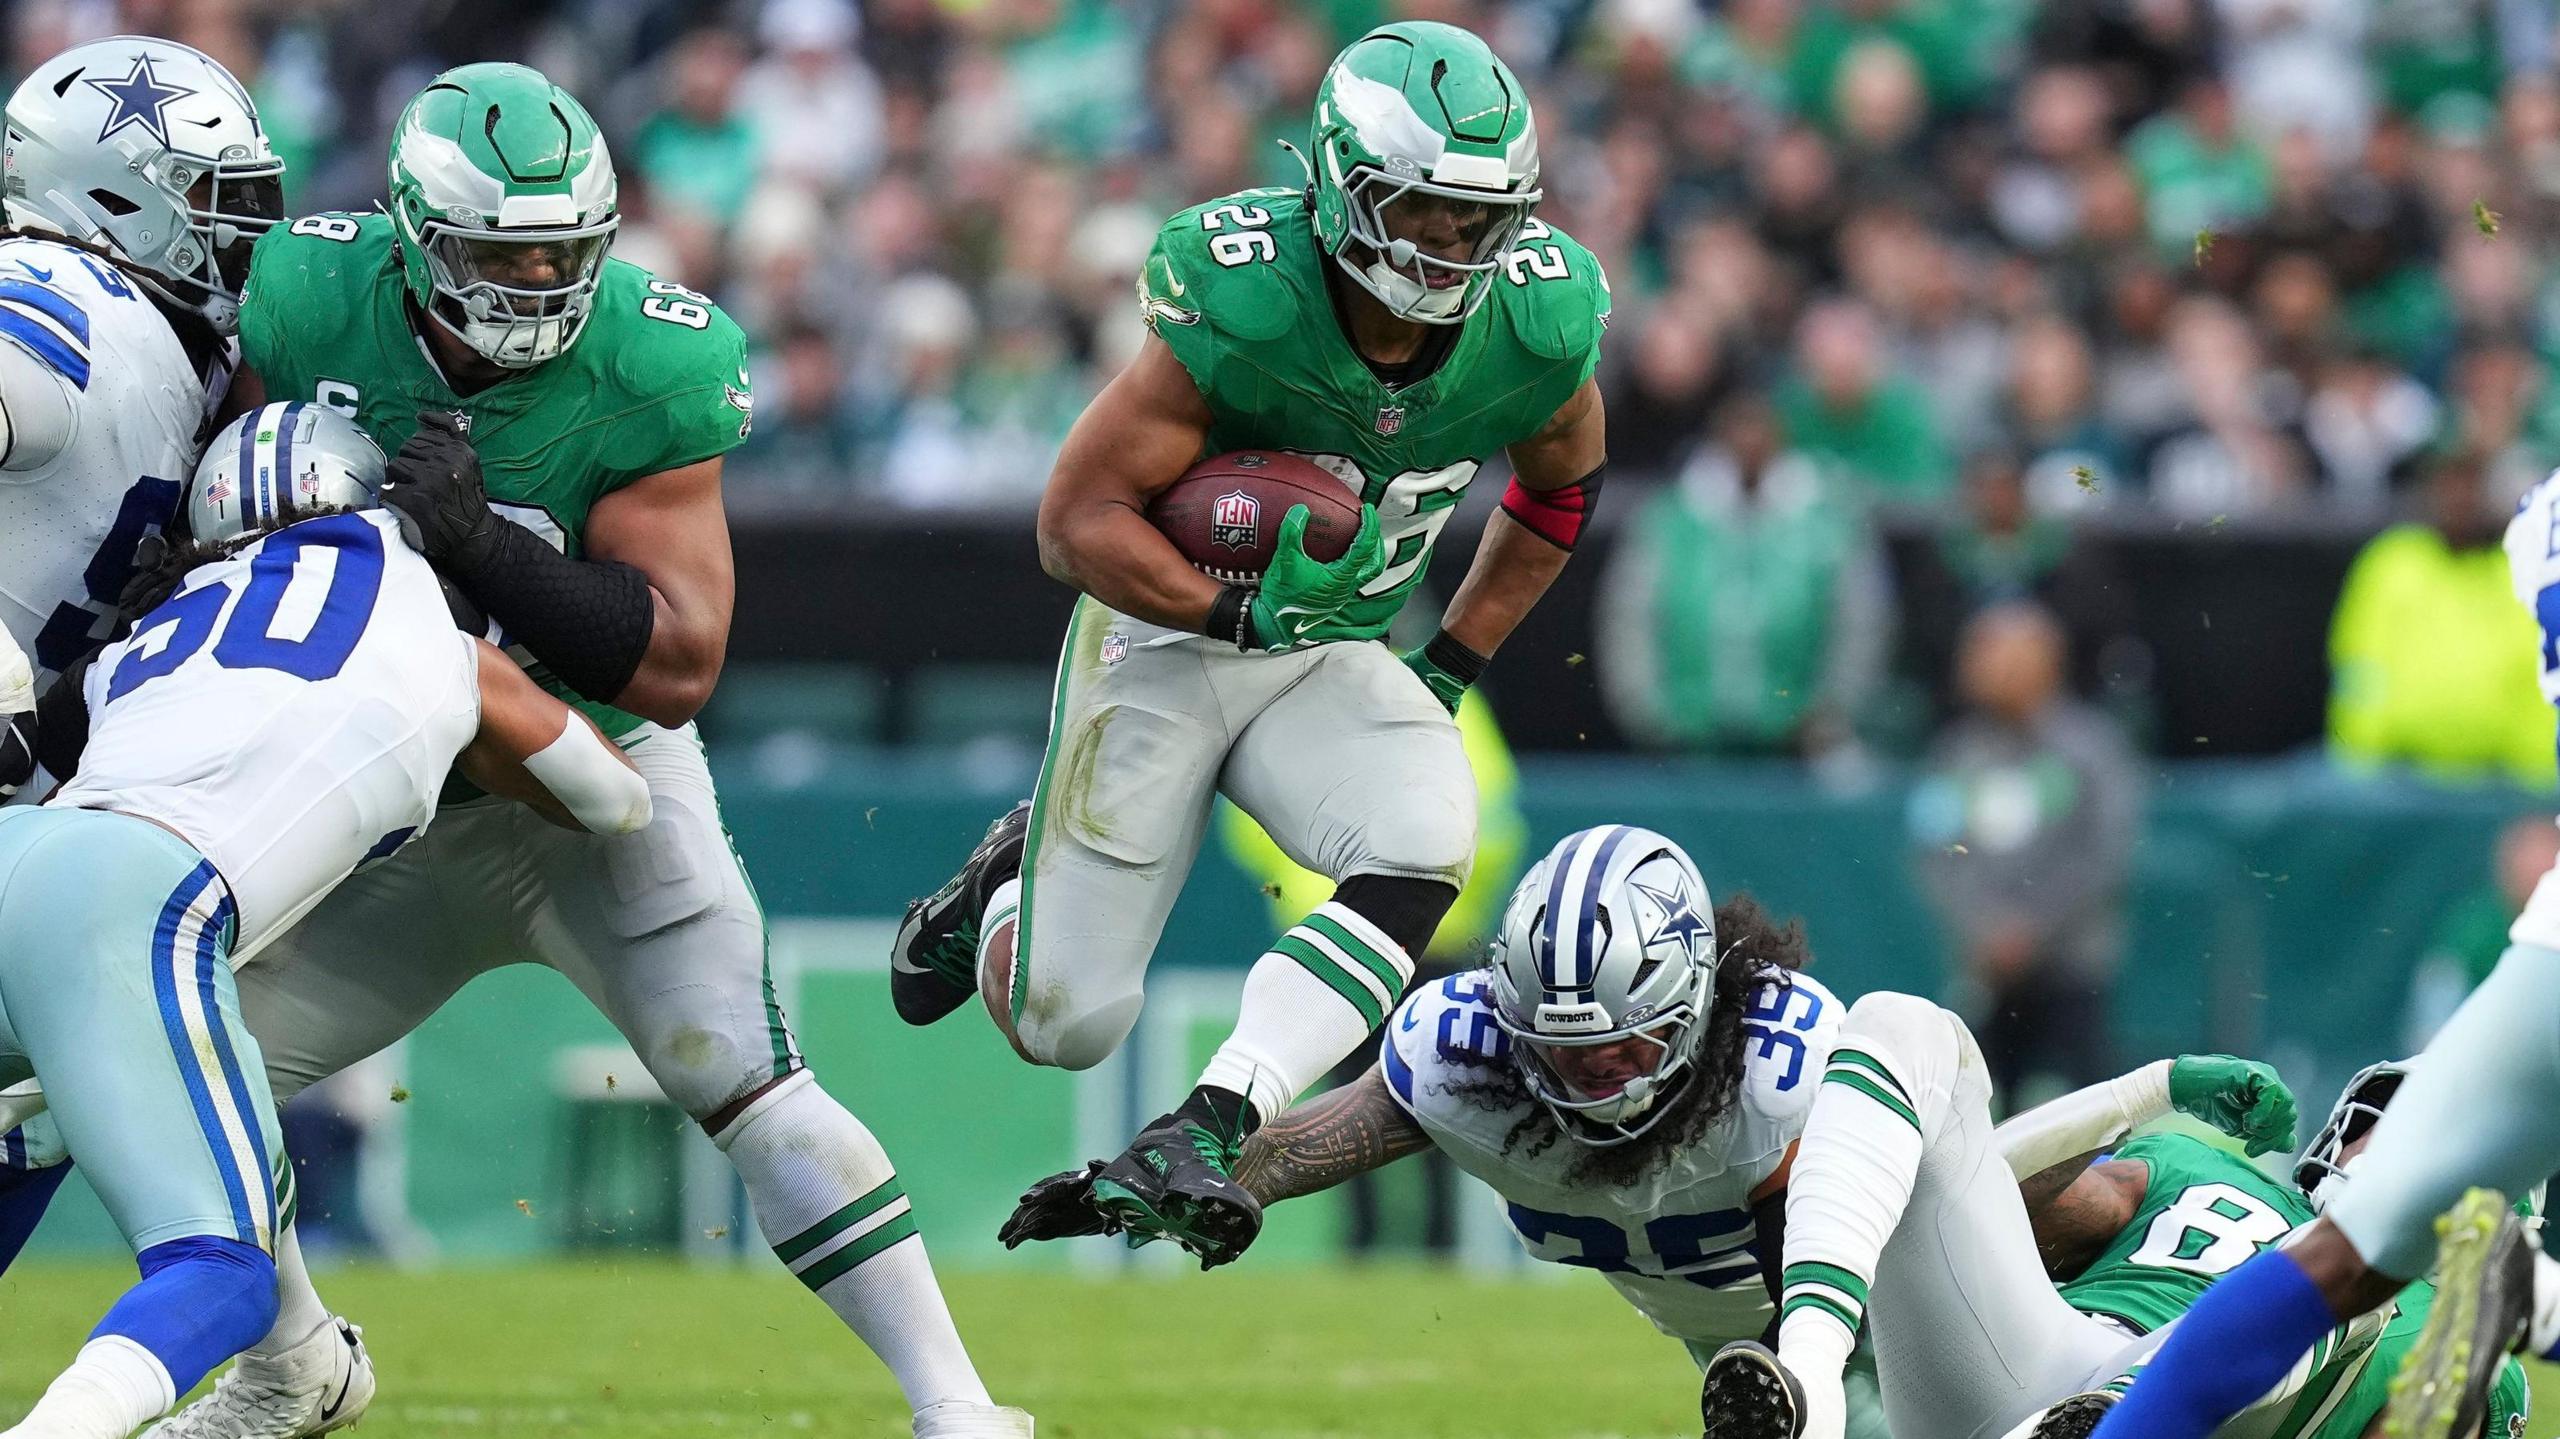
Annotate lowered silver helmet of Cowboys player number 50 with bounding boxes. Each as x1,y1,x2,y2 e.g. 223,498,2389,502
187,399,384,545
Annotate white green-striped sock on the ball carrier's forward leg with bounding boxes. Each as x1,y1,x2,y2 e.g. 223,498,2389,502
1201,901,1413,1119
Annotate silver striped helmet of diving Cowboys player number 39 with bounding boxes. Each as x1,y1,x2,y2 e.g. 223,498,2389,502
1492,824,1718,1147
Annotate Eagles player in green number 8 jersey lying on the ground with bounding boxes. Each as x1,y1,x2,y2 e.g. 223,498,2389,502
1705,993,2529,1439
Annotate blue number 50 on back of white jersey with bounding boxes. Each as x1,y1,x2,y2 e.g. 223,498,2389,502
108,515,381,704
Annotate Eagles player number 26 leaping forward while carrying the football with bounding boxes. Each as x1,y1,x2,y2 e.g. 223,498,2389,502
893,23,1608,1262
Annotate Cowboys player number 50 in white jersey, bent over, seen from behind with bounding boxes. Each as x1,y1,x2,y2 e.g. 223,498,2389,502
0,405,650,1439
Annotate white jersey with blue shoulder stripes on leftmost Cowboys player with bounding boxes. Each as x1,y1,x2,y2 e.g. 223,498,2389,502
0,238,228,673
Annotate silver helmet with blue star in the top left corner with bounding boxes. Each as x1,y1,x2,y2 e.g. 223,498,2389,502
0,36,284,335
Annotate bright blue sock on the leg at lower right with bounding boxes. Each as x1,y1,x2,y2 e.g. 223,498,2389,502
2094,1250,2337,1439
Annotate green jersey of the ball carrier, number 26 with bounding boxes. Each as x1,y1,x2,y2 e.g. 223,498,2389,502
1137,189,1608,622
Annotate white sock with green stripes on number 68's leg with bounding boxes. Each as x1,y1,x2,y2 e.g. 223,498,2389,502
712,1070,988,1408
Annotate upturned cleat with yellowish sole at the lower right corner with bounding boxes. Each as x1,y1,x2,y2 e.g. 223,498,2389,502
2383,1188,2534,1439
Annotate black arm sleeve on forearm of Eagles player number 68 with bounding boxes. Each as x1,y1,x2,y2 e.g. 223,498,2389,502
451,522,658,704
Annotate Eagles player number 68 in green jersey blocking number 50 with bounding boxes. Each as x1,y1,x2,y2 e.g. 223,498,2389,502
149,64,1032,1439
